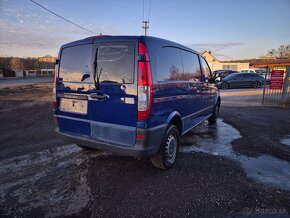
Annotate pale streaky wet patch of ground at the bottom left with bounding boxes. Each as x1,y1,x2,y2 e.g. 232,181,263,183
0,144,105,217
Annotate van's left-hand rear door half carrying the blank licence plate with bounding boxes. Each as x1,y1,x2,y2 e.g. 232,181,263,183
55,44,93,136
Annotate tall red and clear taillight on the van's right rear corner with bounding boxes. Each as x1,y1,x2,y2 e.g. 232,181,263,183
138,43,152,121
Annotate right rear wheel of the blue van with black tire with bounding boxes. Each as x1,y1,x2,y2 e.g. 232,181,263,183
151,125,179,170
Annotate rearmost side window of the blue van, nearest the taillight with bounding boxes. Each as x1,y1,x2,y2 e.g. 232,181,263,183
157,47,183,81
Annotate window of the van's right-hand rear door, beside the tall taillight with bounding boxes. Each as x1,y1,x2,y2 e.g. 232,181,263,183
97,42,134,83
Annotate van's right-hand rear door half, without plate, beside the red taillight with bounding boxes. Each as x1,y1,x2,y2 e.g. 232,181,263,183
89,42,138,146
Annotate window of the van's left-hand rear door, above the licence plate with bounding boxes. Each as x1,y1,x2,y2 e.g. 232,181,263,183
59,44,92,82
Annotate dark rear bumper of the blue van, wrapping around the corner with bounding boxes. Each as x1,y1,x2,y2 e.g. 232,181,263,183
55,124,166,157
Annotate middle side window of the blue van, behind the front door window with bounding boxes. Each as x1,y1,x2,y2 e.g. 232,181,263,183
180,50,201,82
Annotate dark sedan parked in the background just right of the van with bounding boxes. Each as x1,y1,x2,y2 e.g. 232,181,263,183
216,73,264,89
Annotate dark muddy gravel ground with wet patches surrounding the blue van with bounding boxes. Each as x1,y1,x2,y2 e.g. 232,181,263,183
0,83,290,217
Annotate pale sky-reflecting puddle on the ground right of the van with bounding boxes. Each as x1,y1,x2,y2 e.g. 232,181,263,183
180,119,290,190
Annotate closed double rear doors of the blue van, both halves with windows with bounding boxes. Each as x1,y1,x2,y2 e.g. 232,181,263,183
56,41,138,146
